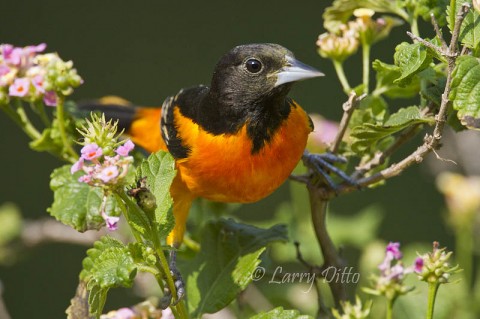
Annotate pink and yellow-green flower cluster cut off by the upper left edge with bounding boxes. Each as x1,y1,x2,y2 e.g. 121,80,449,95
0,43,83,106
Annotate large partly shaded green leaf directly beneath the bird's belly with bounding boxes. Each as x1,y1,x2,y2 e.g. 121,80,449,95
183,219,287,317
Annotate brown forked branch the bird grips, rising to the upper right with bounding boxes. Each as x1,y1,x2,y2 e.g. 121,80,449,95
297,5,469,306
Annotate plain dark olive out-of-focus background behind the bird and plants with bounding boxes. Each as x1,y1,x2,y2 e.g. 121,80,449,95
0,0,452,318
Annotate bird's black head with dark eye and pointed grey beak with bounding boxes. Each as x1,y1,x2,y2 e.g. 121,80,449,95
211,43,323,108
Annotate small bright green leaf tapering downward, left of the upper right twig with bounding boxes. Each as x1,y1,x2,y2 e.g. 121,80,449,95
393,42,432,86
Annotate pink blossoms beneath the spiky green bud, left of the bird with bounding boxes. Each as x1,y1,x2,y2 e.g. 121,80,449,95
70,140,135,186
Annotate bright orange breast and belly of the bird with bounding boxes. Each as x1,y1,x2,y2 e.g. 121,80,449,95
174,102,311,203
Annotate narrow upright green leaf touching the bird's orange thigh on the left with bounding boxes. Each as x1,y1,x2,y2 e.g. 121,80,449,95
137,151,176,238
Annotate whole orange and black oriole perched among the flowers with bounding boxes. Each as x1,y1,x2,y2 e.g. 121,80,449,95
82,44,323,247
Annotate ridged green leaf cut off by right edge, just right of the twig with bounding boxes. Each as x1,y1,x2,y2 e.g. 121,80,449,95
449,56,480,130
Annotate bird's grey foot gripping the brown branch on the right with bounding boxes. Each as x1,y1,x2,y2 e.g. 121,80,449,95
302,151,360,193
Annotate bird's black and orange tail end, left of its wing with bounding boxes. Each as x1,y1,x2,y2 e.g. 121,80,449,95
73,96,167,152
